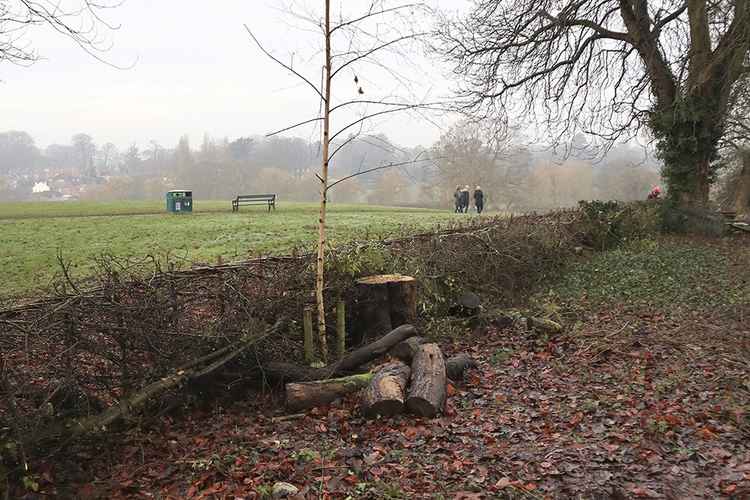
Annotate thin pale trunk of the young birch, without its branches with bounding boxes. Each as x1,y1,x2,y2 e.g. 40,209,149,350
315,0,331,363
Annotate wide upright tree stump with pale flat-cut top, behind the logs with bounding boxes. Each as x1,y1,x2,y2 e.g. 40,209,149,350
351,274,417,344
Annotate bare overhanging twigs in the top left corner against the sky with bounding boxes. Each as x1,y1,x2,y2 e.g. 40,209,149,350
0,0,122,70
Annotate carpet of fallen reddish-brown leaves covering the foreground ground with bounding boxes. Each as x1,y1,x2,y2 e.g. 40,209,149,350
16,236,750,499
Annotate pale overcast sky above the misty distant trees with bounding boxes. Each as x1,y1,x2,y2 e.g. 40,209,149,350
0,0,466,151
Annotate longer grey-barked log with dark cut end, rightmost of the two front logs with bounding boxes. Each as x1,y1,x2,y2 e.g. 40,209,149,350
406,344,446,418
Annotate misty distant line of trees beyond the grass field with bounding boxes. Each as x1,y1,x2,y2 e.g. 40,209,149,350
0,129,659,211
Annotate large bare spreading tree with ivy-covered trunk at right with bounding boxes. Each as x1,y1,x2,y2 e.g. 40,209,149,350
441,0,750,206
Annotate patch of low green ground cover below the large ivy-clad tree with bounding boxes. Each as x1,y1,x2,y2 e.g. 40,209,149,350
550,238,750,309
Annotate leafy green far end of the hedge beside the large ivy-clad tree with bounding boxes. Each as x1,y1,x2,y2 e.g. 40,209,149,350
578,200,661,250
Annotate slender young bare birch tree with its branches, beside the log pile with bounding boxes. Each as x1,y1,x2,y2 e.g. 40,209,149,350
247,0,444,361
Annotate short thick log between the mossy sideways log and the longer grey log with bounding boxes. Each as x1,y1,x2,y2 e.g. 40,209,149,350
361,361,411,418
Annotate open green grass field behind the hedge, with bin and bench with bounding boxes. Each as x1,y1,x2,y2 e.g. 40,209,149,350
0,201,460,298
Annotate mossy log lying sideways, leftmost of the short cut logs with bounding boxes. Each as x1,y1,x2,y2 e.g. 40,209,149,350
286,373,374,411
